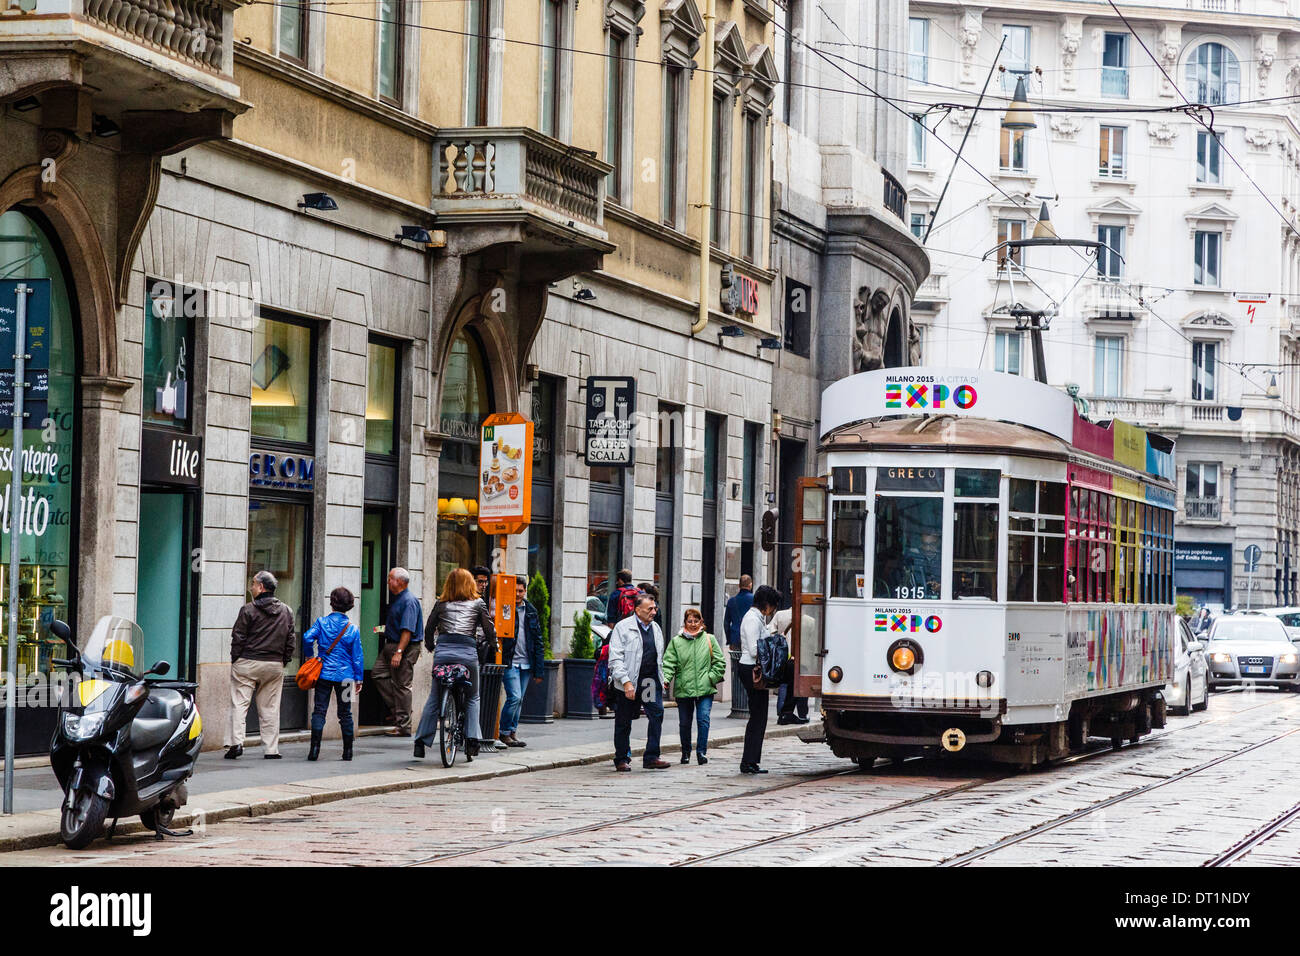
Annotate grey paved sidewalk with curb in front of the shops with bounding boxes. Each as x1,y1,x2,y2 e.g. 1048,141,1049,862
0,702,803,852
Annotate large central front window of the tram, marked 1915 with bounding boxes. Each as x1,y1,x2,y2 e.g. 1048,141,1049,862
872,494,944,601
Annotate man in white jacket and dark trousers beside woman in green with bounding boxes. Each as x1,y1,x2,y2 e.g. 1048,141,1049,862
610,592,671,773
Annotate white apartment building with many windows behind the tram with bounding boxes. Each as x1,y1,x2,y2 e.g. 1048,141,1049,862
907,0,1300,607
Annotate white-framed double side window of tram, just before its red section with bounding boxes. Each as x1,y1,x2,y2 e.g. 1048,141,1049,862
1006,479,1066,604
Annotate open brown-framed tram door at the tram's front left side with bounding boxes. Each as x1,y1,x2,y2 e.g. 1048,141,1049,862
790,477,829,697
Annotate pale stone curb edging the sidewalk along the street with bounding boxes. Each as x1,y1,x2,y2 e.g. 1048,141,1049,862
0,721,818,853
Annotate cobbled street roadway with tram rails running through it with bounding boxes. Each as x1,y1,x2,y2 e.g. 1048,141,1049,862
0,691,1300,866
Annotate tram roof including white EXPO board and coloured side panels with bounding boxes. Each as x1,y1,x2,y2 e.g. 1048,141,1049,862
822,367,1174,480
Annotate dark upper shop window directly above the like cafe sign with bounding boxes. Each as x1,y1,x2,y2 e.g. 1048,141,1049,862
140,278,196,432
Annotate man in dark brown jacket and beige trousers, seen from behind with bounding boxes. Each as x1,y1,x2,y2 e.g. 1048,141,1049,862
226,571,294,760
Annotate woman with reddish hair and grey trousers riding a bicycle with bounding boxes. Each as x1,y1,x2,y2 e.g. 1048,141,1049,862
415,567,497,757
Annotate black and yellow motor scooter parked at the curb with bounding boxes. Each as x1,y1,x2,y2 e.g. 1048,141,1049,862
49,617,203,849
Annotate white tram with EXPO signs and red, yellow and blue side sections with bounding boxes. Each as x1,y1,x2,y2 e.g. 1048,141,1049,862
792,367,1177,767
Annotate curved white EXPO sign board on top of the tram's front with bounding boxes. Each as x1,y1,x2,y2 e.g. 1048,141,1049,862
822,367,1074,442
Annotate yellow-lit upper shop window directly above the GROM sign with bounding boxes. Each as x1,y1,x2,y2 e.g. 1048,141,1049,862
251,315,315,445
